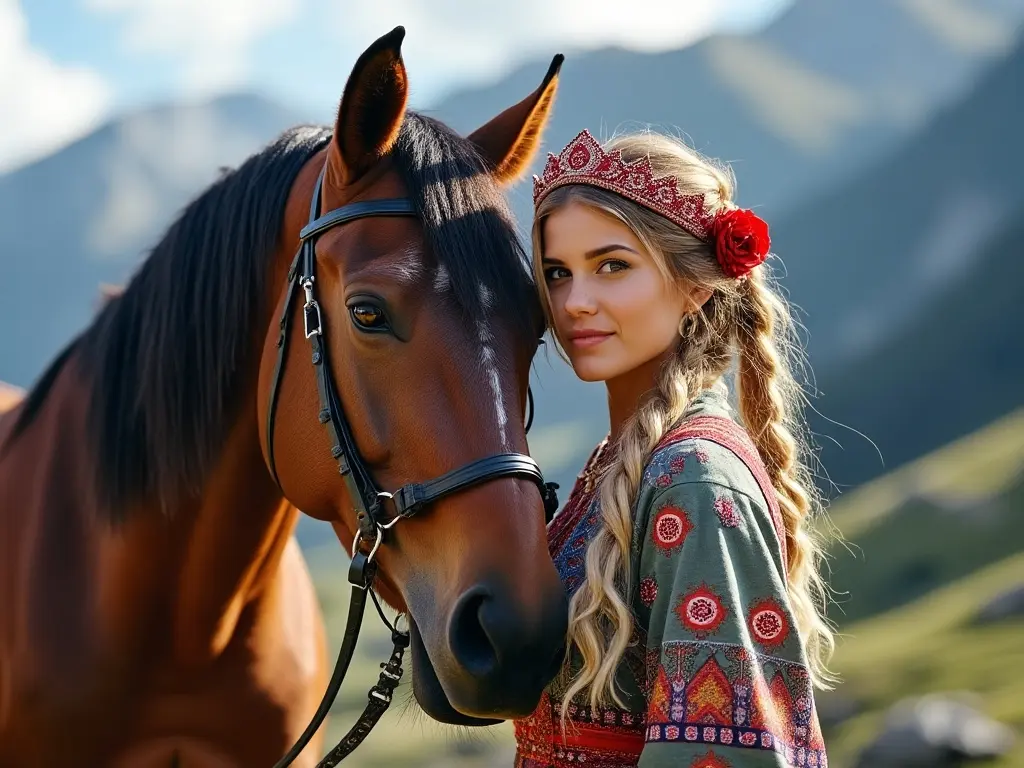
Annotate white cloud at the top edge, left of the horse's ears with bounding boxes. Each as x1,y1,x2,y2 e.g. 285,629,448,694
85,0,300,93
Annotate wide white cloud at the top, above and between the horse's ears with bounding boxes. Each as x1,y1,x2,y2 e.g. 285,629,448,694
331,0,729,103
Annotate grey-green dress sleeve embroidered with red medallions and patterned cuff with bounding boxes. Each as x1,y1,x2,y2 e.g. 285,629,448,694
635,448,826,768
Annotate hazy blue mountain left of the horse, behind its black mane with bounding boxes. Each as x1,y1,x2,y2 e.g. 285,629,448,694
0,94,301,386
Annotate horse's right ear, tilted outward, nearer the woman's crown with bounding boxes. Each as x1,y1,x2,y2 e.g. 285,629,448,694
469,53,565,183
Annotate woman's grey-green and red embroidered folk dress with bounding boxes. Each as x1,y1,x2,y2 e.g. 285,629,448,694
515,386,827,768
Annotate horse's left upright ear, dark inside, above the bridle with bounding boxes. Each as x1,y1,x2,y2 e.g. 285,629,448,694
328,27,409,185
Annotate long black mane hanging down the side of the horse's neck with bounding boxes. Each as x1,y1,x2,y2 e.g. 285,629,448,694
12,126,331,522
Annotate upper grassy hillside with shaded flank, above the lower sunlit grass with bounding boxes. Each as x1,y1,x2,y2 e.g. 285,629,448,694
829,409,1024,625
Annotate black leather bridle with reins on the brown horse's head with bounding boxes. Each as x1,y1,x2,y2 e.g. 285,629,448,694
266,164,558,768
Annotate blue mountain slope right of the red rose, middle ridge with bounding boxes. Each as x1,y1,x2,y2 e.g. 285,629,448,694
772,31,1024,374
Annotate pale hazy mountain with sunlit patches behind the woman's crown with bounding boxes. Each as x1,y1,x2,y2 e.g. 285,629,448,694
433,0,1024,221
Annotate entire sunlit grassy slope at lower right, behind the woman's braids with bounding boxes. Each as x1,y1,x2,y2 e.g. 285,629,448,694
822,409,1024,768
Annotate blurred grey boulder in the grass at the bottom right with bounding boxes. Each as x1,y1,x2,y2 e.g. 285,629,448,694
857,694,1015,768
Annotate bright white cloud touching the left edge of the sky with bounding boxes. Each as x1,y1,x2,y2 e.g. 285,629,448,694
0,0,111,172
